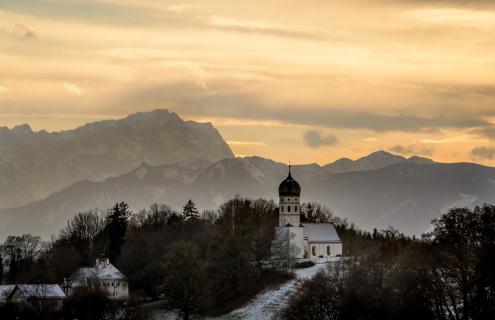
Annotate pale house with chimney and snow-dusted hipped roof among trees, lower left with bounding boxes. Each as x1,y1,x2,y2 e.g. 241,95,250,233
66,258,129,300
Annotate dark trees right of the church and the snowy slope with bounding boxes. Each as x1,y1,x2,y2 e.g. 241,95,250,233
281,205,495,320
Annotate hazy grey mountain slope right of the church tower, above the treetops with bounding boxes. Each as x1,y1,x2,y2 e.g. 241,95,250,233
303,163,495,234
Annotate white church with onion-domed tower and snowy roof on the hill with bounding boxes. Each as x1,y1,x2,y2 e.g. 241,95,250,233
273,166,342,263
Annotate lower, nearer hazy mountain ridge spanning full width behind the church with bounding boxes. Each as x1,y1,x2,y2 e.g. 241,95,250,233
0,157,495,236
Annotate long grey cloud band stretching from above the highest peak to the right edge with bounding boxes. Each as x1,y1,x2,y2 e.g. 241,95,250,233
112,83,491,132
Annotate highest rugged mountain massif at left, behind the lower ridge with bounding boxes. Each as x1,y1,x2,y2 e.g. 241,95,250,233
0,110,233,208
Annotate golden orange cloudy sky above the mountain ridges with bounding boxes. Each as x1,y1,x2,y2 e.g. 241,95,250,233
0,0,495,166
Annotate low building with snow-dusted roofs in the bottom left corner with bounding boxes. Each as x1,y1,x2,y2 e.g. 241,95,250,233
0,284,66,310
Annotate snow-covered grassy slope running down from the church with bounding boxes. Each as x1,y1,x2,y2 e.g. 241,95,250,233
153,263,336,320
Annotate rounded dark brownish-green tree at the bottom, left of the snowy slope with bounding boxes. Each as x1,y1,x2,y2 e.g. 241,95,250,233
163,242,205,320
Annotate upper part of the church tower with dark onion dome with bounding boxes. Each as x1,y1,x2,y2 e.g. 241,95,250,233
278,165,301,227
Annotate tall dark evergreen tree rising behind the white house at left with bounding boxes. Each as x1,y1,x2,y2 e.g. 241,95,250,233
105,202,131,263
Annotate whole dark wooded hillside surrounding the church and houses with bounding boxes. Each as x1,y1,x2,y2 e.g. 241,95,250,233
0,197,495,320
